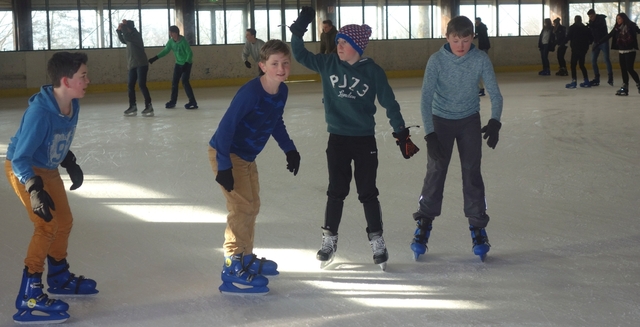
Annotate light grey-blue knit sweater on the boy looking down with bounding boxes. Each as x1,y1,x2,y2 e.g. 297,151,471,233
420,44,502,134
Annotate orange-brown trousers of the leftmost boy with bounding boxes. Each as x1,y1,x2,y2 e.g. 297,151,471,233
4,160,73,273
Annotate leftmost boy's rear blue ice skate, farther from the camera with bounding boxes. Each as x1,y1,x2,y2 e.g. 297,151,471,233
47,256,98,295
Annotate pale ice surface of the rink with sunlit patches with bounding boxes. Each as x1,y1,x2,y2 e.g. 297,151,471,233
0,70,640,327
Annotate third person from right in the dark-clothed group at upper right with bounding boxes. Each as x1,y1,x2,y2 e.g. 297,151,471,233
566,15,593,89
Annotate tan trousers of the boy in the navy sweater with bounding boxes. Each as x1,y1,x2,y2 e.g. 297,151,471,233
209,147,260,256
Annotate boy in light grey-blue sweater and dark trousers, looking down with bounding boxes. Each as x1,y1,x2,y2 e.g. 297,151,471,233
411,16,502,261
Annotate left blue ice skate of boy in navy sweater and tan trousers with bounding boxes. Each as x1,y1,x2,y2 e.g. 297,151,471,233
218,256,269,295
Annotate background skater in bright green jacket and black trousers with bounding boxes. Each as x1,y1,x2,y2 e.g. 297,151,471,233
149,25,198,109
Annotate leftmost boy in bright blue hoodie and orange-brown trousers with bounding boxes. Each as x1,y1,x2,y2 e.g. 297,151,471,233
4,52,98,323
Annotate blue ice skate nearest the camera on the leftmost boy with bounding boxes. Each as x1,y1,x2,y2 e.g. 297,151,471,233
13,267,69,324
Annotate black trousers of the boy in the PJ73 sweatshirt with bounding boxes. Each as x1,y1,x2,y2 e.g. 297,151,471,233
324,134,382,234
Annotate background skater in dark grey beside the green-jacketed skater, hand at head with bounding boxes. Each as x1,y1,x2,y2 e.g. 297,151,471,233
116,19,153,116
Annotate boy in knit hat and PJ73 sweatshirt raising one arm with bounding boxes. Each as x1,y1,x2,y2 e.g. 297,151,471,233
290,7,420,269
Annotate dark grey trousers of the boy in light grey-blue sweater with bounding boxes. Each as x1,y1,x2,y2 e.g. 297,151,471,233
413,114,489,228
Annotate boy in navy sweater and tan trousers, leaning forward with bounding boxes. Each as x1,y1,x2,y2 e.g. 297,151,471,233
209,40,300,294
